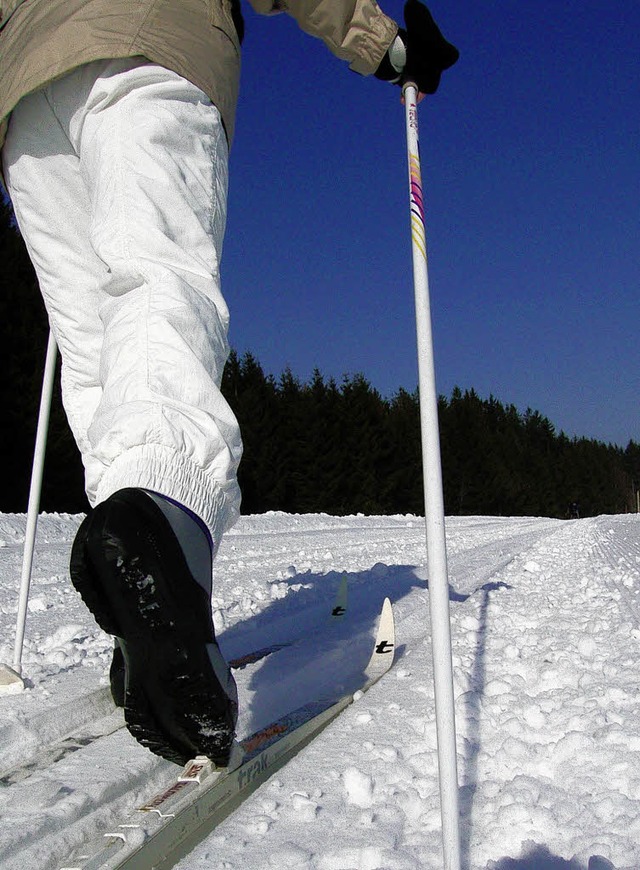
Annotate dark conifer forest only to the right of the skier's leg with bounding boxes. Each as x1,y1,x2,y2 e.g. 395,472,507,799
223,353,640,517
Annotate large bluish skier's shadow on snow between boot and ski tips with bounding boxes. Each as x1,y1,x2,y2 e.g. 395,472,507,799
218,563,467,733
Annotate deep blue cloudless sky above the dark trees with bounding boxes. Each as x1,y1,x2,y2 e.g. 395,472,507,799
223,0,640,446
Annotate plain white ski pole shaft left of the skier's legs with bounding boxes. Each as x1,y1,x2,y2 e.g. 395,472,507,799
13,332,57,674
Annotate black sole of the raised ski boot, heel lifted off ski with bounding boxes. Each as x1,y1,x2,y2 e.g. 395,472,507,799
71,489,238,766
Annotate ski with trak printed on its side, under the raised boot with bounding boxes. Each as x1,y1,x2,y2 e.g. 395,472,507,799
60,599,395,870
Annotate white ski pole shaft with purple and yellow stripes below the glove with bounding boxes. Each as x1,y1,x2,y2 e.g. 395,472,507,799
403,83,461,870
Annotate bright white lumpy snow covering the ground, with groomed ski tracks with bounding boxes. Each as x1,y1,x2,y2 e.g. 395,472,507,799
0,513,640,870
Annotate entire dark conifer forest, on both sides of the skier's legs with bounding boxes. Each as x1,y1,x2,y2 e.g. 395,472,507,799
0,202,640,517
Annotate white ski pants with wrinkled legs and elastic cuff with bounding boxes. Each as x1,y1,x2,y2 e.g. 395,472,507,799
2,58,242,542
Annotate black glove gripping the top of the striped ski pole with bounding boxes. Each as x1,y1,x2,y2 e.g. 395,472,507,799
375,0,460,94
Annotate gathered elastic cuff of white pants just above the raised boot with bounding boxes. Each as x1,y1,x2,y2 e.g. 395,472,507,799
95,444,239,551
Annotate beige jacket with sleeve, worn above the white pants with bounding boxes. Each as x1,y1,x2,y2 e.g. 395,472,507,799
0,0,398,146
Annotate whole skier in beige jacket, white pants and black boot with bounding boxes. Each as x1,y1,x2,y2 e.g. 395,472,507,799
0,0,458,765
